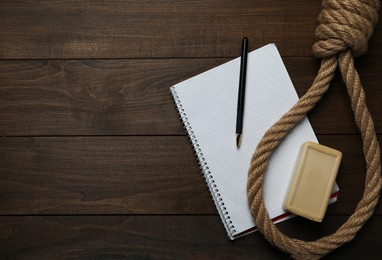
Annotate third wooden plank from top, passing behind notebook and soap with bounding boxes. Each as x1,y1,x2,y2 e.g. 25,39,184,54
0,135,382,215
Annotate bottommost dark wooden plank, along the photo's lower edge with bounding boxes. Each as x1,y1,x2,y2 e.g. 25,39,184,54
0,215,382,259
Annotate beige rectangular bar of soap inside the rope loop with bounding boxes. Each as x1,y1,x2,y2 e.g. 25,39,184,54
284,142,342,222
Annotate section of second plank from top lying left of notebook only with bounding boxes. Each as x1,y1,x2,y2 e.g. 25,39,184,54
0,59,216,135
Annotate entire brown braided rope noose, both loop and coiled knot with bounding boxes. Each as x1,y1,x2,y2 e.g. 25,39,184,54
248,0,382,259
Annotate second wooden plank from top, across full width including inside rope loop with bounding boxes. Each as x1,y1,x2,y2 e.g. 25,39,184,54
0,56,382,136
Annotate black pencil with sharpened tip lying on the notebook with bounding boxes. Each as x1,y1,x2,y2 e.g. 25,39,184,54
236,37,248,148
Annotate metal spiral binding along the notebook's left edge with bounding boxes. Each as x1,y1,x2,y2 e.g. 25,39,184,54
170,87,236,236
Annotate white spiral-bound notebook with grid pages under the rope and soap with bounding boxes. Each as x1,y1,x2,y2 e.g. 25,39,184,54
171,44,338,240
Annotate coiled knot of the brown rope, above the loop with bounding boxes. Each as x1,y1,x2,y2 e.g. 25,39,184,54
313,0,379,58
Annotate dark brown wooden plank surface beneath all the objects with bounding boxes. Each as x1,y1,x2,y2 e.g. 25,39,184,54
0,0,382,259
